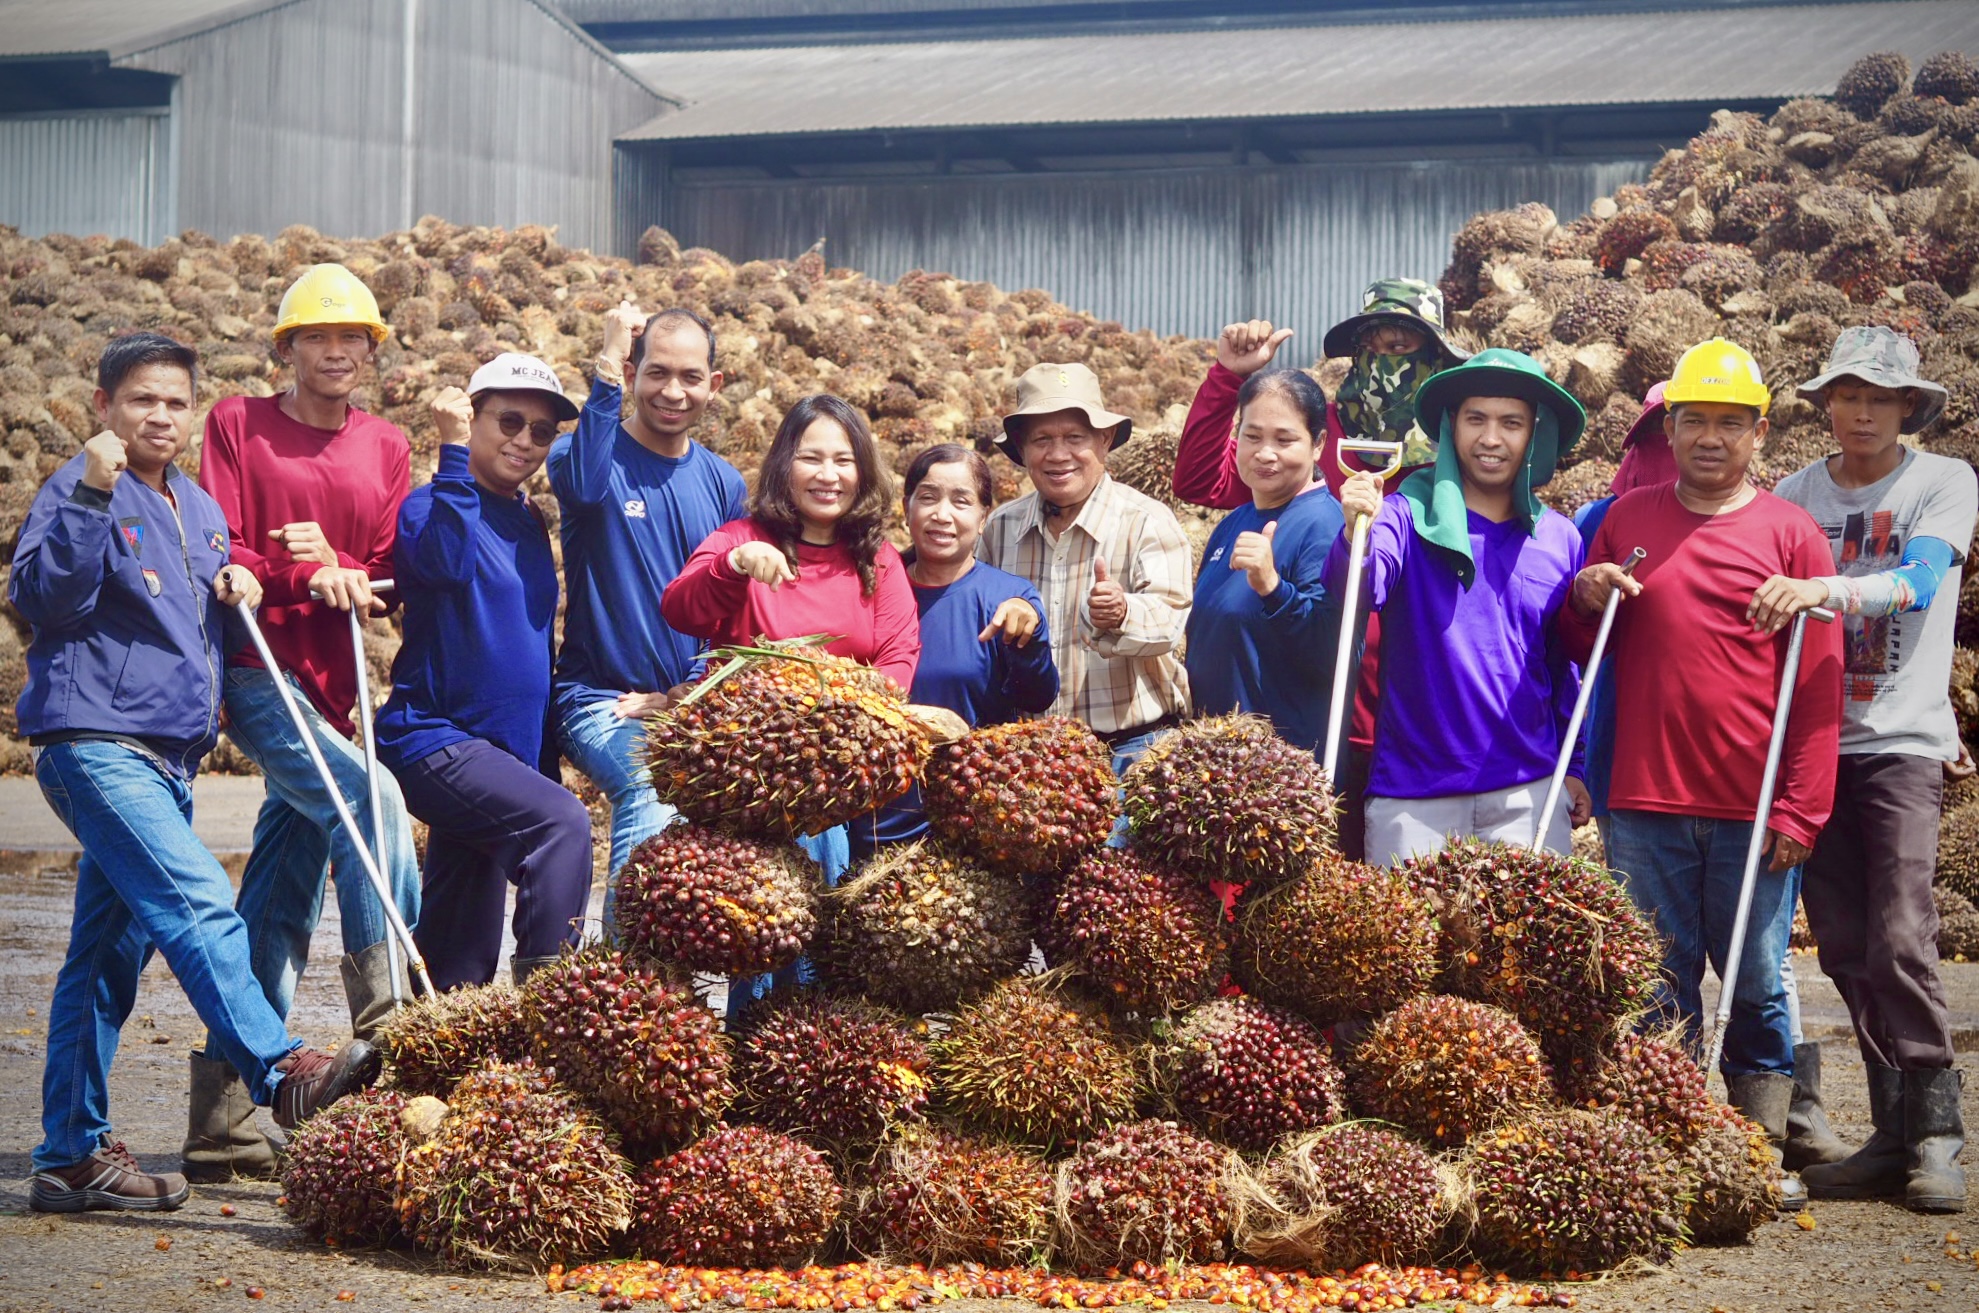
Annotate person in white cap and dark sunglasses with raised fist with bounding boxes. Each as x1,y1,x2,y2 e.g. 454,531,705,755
378,353,592,990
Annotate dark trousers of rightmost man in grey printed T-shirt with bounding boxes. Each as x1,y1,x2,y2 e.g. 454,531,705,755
1801,753,1951,1071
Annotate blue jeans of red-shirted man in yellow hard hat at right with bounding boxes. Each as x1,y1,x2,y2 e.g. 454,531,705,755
1609,810,1795,1077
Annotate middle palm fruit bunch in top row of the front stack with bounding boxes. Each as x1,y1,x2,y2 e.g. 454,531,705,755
920,715,1120,875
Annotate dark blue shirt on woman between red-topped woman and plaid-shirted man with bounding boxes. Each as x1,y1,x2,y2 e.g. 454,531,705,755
853,560,1059,858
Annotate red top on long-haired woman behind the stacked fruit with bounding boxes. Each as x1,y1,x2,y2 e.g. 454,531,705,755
659,519,920,693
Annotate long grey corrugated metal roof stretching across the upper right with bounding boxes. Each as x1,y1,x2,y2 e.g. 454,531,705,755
619,0,1979,141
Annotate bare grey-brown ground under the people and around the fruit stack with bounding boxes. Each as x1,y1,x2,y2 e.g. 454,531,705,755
0,869,1979,1313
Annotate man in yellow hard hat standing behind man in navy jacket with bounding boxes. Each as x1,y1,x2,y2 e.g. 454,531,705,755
184,263,420,1182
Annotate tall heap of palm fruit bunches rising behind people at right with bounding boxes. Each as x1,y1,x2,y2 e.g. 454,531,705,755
1441,51,1979,509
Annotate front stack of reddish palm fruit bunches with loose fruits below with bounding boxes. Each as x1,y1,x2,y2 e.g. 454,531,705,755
285,708,1777,1283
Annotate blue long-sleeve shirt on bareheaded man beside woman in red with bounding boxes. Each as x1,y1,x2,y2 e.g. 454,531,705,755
548,378,748,713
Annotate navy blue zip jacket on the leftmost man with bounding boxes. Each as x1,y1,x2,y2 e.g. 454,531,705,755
8,455,230,778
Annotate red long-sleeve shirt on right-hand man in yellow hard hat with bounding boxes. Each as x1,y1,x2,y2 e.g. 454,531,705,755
1557,483,1842,846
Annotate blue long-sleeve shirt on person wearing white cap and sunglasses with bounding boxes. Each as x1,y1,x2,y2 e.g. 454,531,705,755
378,444,556,770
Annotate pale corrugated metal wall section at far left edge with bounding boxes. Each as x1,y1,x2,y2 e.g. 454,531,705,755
0,113,178,246
